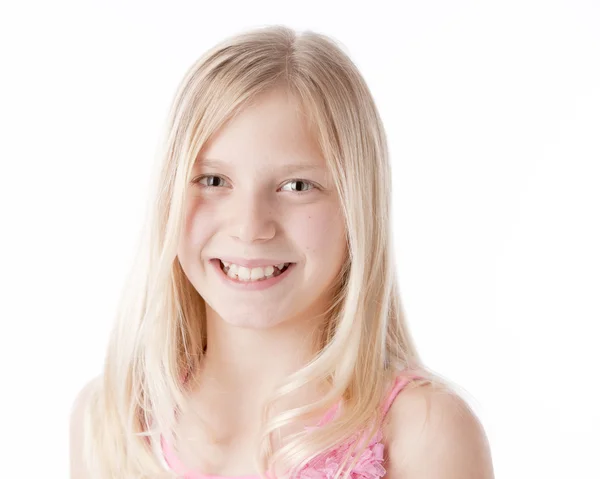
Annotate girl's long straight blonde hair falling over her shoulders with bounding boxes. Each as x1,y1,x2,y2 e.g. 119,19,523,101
84,26,460,479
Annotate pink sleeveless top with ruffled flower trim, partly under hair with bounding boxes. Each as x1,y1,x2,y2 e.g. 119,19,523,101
161,371,420,479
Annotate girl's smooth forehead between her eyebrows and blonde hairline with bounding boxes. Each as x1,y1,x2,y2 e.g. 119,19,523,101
196,90,325,170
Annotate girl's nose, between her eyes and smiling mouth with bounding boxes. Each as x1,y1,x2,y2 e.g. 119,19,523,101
230,189,276,243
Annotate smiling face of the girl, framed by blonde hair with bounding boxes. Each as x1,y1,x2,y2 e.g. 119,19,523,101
178,90,346,328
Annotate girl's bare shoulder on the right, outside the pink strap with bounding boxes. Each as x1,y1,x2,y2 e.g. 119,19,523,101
385,383,494,479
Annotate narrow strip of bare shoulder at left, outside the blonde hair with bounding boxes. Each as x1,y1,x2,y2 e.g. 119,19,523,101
69,376,102,479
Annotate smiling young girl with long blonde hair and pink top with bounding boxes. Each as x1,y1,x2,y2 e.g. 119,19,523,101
71,26,493,479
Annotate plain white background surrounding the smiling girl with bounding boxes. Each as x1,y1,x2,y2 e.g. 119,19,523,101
0,0,600,479
